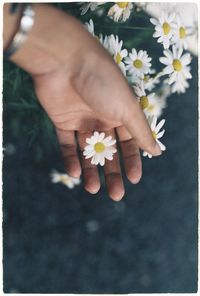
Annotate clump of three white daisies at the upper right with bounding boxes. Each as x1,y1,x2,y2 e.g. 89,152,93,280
150,11,193,93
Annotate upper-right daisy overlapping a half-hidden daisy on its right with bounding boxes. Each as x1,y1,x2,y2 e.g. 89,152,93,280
150,11,175,49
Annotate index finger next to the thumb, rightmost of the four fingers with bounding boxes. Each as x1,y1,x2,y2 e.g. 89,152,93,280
117,126,142,184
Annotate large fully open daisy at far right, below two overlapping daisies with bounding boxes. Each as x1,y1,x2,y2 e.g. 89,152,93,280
159,46,192,84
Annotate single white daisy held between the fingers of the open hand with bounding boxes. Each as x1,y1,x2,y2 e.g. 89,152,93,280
83,131,117,166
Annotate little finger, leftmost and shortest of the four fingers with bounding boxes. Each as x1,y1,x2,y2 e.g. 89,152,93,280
56,128,81,178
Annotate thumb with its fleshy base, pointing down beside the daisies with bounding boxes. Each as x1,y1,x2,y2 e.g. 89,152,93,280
77,50,162,156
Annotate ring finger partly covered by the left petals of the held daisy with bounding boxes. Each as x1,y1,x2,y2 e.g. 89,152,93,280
77,132,101,194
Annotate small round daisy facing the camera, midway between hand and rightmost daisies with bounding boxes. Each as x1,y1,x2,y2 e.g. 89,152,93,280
125,48,151,78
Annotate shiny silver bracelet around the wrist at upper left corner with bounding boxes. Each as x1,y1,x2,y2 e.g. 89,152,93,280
4,4,35,58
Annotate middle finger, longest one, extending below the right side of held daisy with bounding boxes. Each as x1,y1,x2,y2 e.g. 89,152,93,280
104,130,125,201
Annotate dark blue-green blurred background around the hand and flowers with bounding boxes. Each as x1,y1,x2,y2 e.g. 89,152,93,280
3,3,198,293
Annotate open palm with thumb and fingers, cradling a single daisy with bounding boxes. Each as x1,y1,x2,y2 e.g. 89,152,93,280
29,11,160,200
